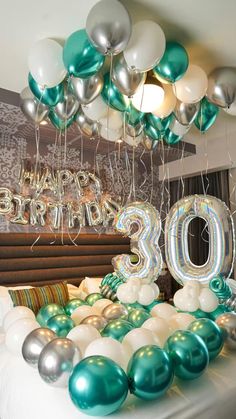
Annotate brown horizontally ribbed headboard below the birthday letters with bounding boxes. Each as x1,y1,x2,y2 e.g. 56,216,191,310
0,233,130,286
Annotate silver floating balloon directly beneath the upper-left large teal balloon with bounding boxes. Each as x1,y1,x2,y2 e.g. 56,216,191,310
70,74,103,105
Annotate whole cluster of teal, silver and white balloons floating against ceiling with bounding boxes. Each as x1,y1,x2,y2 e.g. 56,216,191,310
21,0,236,149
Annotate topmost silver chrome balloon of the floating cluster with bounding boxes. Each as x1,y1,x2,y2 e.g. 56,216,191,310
86,0,132,55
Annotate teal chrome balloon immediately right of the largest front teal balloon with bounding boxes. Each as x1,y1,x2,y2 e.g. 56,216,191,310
127,345,174,400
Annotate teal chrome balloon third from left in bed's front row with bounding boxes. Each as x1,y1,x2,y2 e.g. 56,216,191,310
165,330,209,380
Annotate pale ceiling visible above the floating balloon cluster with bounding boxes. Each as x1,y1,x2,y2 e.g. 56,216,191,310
0,0,236,92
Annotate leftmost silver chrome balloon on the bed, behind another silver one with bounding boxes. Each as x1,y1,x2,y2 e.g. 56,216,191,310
22,327,57,368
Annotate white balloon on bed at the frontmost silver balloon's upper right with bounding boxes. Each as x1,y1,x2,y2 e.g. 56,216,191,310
67,324,101,356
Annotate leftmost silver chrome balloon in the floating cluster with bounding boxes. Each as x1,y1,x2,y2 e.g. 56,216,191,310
20,87,49,125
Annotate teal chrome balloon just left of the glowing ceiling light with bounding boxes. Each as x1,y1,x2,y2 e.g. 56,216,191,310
101,73,130,112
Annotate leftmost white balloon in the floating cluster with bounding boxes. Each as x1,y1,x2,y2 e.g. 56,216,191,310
28,39,66,87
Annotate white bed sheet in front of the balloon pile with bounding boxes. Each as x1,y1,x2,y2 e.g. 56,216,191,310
0,335,236,419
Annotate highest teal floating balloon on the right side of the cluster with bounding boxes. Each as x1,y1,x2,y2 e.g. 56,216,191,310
153,42,189,83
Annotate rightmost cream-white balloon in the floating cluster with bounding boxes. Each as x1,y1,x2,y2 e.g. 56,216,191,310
173,65,208,103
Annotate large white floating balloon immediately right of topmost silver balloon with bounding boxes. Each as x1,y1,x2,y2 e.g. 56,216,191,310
124,20,166,71
